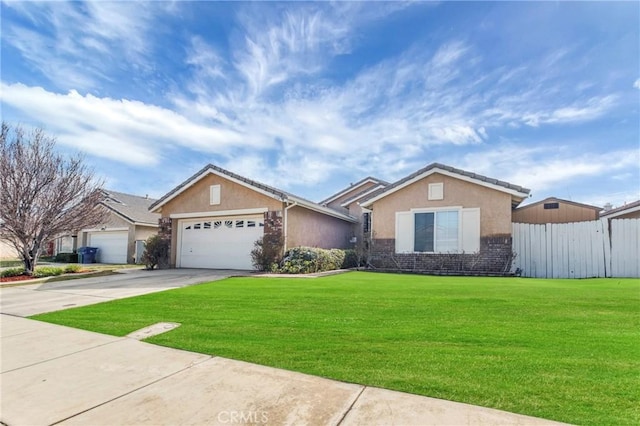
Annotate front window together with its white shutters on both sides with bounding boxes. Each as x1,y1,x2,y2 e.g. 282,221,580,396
396,207,480,253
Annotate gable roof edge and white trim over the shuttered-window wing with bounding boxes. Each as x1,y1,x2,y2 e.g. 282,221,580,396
360,163,531,207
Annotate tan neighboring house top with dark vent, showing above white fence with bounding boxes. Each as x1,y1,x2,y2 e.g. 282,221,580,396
511,197,602,224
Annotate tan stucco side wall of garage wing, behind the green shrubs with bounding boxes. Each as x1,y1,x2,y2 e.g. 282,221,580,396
286,206,353,249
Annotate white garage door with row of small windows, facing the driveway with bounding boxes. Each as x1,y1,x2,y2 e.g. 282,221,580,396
178,216,264,269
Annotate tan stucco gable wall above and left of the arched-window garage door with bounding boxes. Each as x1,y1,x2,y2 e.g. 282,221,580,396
160,174,283,268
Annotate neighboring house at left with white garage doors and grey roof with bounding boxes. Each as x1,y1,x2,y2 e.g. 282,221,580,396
76,190,160,263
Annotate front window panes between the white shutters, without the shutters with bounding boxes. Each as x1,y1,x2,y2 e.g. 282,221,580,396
413,210,458,253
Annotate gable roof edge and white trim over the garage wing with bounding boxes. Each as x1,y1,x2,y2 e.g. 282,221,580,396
149,164,358,223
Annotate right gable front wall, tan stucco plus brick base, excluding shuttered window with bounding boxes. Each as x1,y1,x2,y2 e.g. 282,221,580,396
370,173,513,274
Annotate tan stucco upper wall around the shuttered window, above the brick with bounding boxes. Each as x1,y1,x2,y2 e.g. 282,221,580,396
372,173,511,239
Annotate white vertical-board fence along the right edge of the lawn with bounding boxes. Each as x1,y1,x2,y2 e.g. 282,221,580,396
513,219,640,278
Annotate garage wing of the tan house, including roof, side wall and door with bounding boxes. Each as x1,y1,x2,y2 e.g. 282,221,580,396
150,164,358,269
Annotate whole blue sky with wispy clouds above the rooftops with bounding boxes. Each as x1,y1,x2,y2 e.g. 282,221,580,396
0,1,640,206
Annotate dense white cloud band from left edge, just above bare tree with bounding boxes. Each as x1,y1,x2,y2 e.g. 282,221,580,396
0,83,248,165
